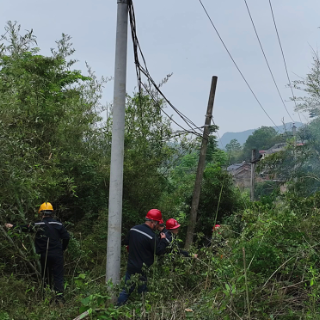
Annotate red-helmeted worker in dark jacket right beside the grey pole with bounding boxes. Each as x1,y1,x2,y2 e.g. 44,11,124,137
117,209,168,306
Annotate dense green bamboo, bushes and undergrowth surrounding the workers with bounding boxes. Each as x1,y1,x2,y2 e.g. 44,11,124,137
0,23,320,320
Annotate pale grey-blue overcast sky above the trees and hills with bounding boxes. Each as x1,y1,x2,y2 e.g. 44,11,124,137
0,0,320,140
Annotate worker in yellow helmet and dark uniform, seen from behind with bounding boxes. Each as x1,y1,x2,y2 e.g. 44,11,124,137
5,202,70,304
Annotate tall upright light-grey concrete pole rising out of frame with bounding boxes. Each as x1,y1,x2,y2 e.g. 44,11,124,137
106,0,128,284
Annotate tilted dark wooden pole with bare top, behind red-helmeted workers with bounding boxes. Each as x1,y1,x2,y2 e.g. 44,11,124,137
185,77,218,249
